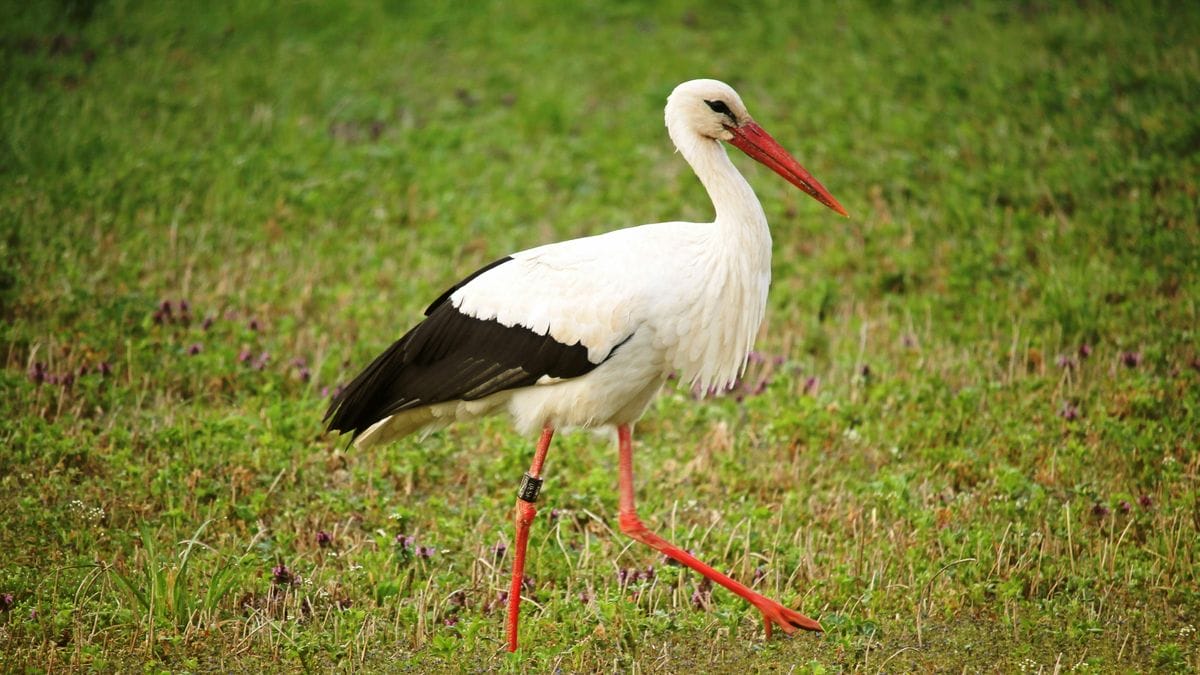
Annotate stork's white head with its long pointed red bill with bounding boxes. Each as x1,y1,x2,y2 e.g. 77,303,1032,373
666,79,848,215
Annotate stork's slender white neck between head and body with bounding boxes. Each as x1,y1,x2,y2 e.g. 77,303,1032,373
668,127,770,229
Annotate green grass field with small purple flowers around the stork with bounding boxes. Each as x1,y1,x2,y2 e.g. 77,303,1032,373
0,0,1200,673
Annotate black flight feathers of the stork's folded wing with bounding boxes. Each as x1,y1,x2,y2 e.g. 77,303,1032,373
325,265,599,437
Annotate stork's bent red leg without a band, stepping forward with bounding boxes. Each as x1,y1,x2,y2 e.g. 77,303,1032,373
617,424,823,638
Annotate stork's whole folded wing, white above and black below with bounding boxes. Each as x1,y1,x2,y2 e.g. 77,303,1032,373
325,223,703,436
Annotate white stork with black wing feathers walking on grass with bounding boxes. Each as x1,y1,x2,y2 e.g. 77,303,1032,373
325,79,847,651
